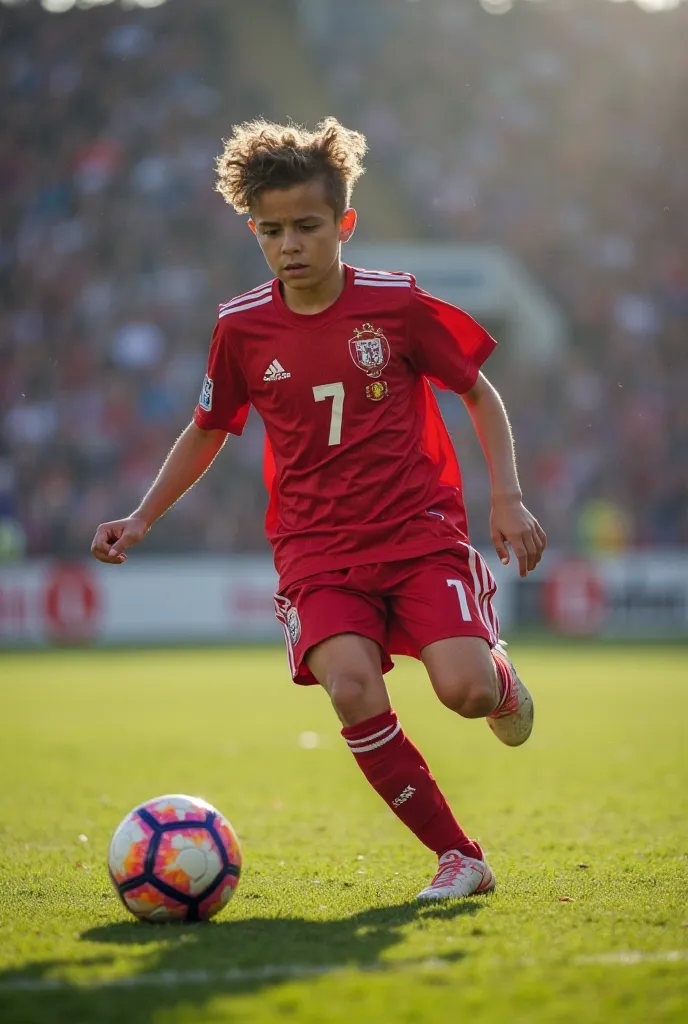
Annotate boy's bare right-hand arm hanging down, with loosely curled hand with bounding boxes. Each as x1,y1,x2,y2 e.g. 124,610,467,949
461,373,547,577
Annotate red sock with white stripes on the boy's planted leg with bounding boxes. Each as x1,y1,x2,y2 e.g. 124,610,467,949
342,709,482,860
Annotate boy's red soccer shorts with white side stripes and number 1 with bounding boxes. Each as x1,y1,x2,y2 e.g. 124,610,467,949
274,544,500,684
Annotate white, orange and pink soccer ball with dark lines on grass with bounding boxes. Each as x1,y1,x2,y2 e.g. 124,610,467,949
108,794,242,922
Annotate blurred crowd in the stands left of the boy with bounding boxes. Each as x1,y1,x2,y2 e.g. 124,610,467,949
0,0,266,557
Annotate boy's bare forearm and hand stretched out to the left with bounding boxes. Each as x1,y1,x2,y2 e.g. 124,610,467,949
91,422,227,565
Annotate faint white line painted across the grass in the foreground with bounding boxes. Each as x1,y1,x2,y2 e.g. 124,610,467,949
0,949,688,993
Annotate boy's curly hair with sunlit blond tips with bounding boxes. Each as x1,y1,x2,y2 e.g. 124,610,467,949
215,117,368,217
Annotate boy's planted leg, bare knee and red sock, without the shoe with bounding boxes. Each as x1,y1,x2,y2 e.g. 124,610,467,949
306,633,482,860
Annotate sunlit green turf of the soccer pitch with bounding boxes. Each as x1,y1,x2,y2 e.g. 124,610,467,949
0,645,688,1024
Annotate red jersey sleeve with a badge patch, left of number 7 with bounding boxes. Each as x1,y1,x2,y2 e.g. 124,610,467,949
194,321,251,434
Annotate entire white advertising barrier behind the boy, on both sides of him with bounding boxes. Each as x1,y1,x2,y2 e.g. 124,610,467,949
0,551,688,647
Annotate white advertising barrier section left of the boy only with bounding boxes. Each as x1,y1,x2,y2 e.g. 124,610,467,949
0,556,284,646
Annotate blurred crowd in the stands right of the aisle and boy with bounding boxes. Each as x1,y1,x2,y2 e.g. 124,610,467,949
295,0,688,549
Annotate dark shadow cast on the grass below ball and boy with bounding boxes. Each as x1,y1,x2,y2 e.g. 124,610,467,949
0,897,485,1024
